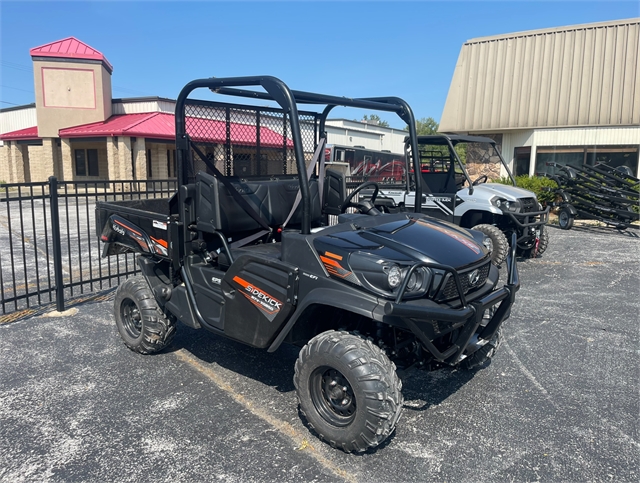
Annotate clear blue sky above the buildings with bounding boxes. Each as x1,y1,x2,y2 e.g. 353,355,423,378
0,0,640,127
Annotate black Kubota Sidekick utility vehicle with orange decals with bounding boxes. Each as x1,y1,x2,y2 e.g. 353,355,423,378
96,76,519,451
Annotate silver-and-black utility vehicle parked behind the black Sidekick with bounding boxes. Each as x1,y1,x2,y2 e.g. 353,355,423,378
376,134,549,266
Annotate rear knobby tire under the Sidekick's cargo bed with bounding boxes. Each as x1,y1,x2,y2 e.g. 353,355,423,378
114,277,176,354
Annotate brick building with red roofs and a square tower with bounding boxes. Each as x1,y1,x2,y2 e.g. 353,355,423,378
0,37,406,183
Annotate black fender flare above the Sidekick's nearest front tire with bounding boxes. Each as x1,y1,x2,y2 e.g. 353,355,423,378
267,288,386,352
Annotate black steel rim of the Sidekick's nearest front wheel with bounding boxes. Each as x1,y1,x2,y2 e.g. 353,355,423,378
309,366,356,427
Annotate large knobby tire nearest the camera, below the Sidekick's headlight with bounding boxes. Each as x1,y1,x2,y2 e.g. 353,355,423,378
293,330,403,453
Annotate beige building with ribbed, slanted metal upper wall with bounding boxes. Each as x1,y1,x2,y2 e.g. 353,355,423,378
440,18,640,180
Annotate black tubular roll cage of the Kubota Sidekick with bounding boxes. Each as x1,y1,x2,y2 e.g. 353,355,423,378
175,76,422,235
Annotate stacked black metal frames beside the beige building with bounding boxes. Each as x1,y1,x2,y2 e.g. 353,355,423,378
547,163,640,230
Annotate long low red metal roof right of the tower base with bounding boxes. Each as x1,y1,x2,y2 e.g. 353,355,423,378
60,112,293,148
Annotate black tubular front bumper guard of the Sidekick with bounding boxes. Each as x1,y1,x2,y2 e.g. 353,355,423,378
384,234,520,364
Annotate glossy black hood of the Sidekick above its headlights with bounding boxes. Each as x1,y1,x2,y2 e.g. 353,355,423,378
314,215,489,269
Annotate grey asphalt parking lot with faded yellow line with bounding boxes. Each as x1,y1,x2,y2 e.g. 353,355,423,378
0,227,640,482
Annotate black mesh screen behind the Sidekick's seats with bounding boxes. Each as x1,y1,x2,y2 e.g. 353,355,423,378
185,100,319,182
